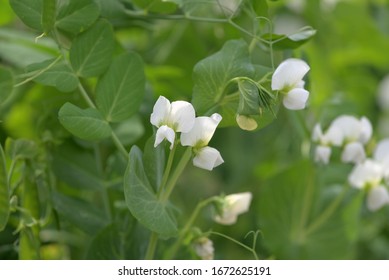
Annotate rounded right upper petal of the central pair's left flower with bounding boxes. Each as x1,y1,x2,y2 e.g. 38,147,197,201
169,101,196,132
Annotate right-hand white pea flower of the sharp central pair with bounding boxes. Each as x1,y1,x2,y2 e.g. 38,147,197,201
181,113,224,170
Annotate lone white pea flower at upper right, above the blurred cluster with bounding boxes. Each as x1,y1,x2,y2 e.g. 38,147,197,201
271,58,310,110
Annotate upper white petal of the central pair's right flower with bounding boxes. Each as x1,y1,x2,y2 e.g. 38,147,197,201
181,113,222,147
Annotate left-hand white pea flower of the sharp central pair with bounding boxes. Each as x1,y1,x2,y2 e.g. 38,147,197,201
150,96,195,149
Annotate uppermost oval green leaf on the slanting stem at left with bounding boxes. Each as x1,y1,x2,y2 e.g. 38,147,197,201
69,19,115,77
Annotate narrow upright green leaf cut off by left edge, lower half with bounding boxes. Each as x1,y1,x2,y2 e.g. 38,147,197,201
0,145,10,231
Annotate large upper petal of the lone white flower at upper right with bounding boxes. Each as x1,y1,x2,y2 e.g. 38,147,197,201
271,58,309,90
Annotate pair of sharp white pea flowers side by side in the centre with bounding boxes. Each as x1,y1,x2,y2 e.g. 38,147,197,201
150,96,224,170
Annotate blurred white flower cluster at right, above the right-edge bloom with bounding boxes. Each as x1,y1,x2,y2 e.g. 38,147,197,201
312,115,373,164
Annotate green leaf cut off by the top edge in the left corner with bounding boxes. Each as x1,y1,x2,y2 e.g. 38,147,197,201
9,0,43,31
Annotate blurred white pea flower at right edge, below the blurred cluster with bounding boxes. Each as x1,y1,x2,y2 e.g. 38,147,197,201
348,159,389,211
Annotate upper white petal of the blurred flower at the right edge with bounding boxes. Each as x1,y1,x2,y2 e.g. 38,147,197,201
348,159,384,189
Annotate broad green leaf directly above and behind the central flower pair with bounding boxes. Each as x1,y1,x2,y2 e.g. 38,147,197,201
192,40,254,125
